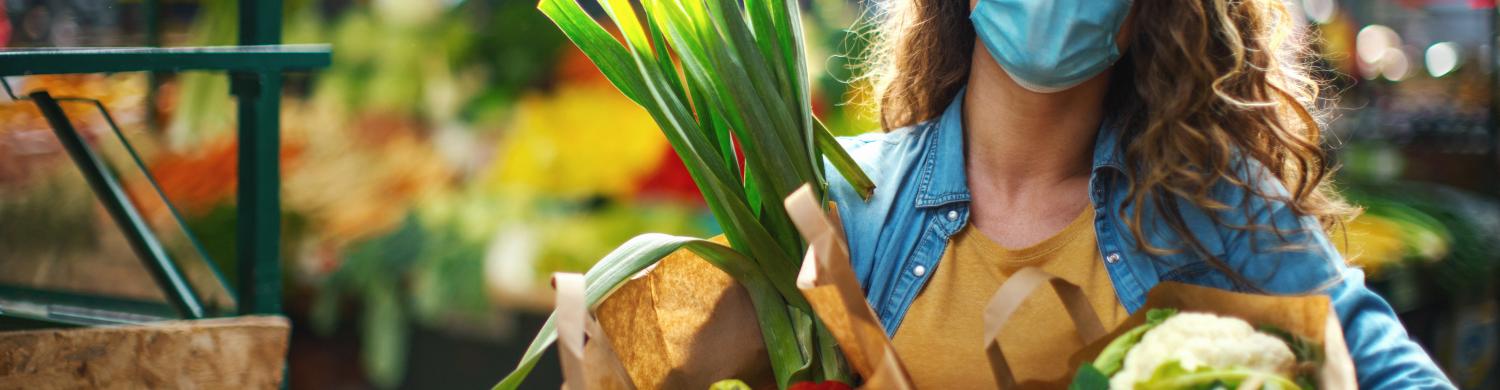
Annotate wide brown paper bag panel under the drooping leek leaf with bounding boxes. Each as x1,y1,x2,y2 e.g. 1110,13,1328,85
594,237,776,389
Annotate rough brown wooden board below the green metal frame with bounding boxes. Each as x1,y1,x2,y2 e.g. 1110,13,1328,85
0,317,291,389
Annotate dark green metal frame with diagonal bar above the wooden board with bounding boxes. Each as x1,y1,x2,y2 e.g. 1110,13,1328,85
0,0,332,324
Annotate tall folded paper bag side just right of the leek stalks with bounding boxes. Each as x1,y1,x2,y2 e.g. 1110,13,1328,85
786,186,912,389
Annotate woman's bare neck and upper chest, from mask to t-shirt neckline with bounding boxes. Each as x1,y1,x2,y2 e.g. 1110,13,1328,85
963,45,1109,248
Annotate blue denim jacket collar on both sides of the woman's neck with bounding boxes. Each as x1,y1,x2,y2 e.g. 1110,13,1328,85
917,89,1125,209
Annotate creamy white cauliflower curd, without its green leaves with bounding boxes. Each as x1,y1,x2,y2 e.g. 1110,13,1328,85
1110,312,1296,389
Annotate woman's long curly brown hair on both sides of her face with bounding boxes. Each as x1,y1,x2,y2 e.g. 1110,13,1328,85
864,0,1358,284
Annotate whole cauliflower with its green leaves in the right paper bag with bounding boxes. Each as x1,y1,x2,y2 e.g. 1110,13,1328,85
1073,309,1322,389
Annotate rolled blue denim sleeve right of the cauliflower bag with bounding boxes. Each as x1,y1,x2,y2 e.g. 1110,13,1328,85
1328,267,1454,389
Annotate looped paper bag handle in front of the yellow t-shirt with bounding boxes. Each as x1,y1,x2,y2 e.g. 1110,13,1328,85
984,267,1104,389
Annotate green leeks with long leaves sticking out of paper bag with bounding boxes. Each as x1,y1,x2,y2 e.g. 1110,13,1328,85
495,0,875,389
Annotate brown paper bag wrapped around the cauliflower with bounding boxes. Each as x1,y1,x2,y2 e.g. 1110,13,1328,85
1070,282,1359,390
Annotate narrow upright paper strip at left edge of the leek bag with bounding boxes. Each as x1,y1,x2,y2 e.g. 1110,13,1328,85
552,273,636,390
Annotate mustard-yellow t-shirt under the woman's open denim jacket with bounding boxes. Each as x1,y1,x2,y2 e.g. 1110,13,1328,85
894,209,1130,389
